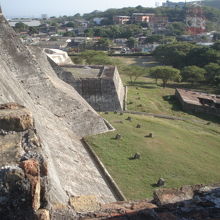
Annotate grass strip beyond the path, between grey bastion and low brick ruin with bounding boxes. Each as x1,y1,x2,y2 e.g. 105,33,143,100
122,76,220,122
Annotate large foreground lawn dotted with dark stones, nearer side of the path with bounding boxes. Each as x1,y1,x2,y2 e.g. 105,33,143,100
87,113,220,199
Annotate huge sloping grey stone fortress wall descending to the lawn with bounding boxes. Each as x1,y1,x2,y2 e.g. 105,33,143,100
0,15,116,205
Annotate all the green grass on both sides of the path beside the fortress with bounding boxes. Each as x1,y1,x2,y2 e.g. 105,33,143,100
87,57,220,199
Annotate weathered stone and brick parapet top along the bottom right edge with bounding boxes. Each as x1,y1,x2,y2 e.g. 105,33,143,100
80,184,220,220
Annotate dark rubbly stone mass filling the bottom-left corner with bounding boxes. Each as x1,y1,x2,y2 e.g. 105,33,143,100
0,166,34,220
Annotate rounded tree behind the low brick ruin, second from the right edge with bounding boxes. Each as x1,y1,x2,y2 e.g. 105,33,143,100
181,66,206,84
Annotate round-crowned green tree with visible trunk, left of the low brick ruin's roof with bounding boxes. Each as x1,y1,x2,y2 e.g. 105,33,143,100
150,66,181,88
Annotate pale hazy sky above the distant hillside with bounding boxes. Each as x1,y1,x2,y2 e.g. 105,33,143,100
0,0,192,17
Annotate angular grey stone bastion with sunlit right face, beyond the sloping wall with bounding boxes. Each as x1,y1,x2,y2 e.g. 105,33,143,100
45,50,125,112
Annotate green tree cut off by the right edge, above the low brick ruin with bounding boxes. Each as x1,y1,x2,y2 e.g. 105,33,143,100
205,63,220,85
